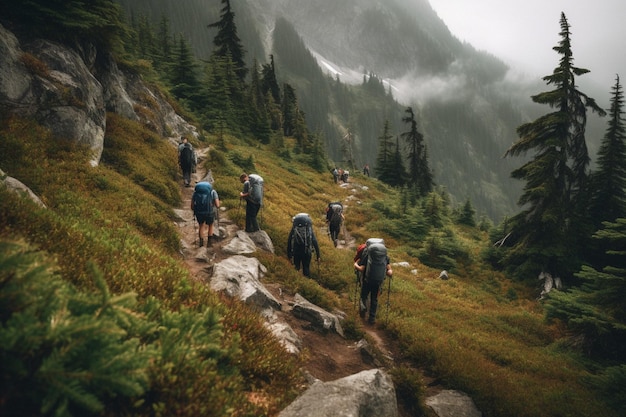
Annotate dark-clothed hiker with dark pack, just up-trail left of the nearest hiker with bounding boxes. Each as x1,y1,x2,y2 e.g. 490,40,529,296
287,213,320,277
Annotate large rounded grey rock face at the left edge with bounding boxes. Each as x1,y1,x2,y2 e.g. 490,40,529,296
0,23,106,166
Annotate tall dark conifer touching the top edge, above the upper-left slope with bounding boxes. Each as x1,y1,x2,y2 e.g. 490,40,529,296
209,0,248,82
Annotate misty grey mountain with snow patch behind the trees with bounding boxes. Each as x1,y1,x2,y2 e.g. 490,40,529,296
121,0,529,221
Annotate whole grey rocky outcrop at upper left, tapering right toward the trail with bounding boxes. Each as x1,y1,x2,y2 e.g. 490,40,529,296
0,25,198,166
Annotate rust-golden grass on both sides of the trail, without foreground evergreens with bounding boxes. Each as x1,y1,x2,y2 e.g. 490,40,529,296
0,109,612,417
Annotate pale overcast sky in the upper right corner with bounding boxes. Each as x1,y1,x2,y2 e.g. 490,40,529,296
429,0,626,94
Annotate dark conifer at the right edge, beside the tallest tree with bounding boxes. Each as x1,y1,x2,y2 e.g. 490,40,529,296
590,76,626,226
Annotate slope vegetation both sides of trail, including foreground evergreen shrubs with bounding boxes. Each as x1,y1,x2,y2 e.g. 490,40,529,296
0,110,616,416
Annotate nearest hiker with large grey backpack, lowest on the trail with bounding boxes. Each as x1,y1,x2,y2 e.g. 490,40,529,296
354,238,393,324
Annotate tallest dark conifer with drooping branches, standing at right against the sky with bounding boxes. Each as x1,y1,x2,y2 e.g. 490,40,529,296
498,14,604,277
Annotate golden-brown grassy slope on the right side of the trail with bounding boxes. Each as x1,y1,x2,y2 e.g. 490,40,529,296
212,136,613,417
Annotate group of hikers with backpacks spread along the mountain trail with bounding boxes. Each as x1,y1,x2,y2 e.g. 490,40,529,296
178,138,393,324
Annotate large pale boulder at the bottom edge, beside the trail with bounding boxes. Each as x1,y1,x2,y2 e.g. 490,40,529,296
278,369,398,417
